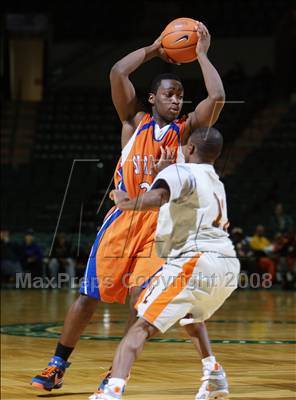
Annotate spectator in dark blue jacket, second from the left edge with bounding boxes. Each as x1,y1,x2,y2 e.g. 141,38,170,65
21,229,43,277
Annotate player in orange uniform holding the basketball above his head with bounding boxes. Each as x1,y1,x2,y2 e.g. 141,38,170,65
32,22,225,391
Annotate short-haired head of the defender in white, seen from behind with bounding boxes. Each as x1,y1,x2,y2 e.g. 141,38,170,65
185,127,223,164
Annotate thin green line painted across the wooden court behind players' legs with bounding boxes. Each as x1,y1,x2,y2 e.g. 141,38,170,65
0,321,296,344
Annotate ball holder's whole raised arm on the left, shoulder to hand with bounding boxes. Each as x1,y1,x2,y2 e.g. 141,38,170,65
110,38,170,144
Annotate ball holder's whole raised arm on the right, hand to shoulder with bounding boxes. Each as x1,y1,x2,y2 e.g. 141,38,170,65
183,22,225,143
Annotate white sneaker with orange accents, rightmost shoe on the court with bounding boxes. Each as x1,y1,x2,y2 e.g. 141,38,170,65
195,363,229,400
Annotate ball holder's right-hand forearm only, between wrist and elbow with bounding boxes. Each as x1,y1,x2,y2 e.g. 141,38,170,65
198,53,225,101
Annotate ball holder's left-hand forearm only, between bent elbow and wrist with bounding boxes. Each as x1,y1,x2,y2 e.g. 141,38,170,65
112,44,158,75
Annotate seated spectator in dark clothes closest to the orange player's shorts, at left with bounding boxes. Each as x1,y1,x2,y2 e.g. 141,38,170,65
48,233,75,287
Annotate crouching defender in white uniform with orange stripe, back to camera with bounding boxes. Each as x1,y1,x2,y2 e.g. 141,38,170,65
97,128,240,400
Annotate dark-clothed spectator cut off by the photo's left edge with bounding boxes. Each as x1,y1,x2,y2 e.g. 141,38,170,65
0,230,23,282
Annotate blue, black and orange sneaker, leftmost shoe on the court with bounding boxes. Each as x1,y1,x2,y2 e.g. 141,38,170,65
31,356,71,392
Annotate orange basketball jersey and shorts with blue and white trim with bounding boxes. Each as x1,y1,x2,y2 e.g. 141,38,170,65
80,114,186,303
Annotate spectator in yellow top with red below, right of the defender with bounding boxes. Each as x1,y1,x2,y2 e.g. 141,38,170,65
250,225,275,282
